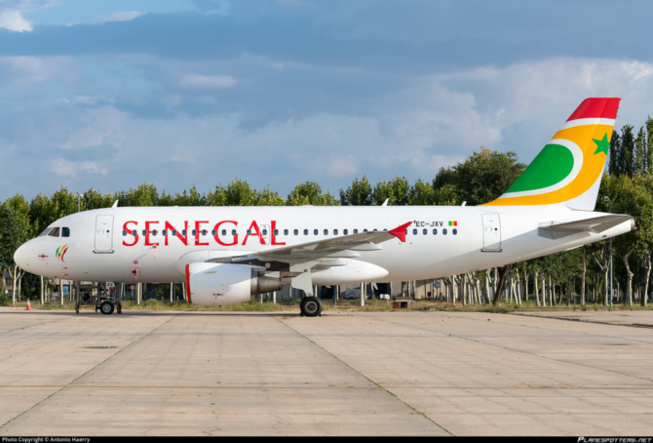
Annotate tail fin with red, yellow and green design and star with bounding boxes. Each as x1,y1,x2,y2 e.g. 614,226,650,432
482,98,620,211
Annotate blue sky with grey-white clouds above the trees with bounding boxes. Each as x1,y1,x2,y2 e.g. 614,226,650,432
0,0,653,200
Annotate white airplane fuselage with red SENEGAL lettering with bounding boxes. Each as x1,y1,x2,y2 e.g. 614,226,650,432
15,206,633,285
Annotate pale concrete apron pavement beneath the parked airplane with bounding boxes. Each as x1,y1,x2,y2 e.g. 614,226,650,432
0,308,653,437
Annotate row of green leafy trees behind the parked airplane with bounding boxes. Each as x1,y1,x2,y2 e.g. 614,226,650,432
0,117,653,306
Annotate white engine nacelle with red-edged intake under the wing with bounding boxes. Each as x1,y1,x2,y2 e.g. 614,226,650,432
186,262,281,306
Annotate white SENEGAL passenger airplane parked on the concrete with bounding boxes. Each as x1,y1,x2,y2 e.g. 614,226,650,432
14,98,635,317
